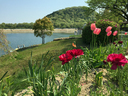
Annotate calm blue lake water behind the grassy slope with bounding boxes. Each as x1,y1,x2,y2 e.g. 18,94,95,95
0,33,74,56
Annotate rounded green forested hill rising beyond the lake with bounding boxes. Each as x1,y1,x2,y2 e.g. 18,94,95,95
47,6,95,28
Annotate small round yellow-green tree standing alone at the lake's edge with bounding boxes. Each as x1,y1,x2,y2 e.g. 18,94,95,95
33,16,54,44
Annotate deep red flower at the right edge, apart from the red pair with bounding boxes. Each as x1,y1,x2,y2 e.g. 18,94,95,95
107,53,128,70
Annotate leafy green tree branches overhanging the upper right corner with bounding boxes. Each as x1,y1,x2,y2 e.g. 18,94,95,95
86,0,128,21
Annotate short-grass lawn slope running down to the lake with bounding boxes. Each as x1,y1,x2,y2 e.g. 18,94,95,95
0,39,85,76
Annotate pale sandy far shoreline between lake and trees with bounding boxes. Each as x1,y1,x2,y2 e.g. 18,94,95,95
3,28,77,34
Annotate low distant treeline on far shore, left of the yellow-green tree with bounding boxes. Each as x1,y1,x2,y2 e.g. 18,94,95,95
0,22,34,29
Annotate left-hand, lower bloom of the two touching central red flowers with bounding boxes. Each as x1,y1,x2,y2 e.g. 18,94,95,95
59,53,73,65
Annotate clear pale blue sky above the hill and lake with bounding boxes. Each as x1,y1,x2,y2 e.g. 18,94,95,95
0,0,87,23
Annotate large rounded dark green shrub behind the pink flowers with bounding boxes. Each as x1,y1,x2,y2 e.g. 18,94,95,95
82,19,120,45
